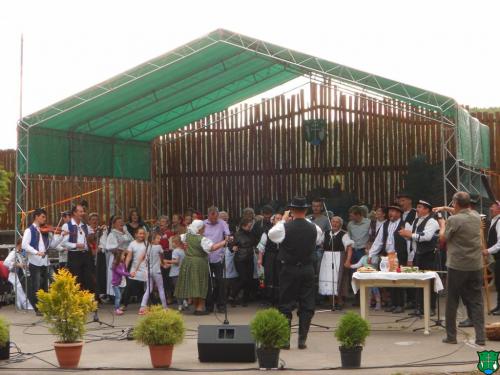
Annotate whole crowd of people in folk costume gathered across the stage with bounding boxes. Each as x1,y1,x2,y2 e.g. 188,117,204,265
4,192,500,348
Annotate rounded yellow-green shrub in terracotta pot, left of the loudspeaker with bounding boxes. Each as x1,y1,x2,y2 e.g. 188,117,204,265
134,305,185,368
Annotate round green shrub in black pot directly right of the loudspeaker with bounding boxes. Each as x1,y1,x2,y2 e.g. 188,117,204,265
250,309,290,369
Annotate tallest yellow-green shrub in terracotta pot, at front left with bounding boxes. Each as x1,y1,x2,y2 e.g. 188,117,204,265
37,268,97,368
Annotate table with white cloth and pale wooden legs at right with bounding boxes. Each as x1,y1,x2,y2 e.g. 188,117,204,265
351,271,443,335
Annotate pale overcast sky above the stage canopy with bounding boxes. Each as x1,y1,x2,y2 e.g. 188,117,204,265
0,0,500,149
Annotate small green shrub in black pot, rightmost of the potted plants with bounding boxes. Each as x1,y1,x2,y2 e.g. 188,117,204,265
335,312,370,368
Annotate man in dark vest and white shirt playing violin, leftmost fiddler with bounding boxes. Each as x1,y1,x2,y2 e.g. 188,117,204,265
22,208,64,315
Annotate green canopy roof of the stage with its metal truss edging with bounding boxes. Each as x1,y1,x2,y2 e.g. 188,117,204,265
16,29,489,234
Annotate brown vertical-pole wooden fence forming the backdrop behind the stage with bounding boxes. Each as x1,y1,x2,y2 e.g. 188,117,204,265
0,83,500,229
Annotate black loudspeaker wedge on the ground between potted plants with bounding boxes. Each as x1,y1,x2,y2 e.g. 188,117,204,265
198,325,256,362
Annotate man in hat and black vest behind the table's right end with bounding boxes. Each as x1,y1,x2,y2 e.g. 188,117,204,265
399,199,439,315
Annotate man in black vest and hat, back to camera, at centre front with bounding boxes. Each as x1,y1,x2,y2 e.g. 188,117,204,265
269,197,323,349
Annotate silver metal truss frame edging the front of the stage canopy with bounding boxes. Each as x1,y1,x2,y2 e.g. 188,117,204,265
15,29,488,244
